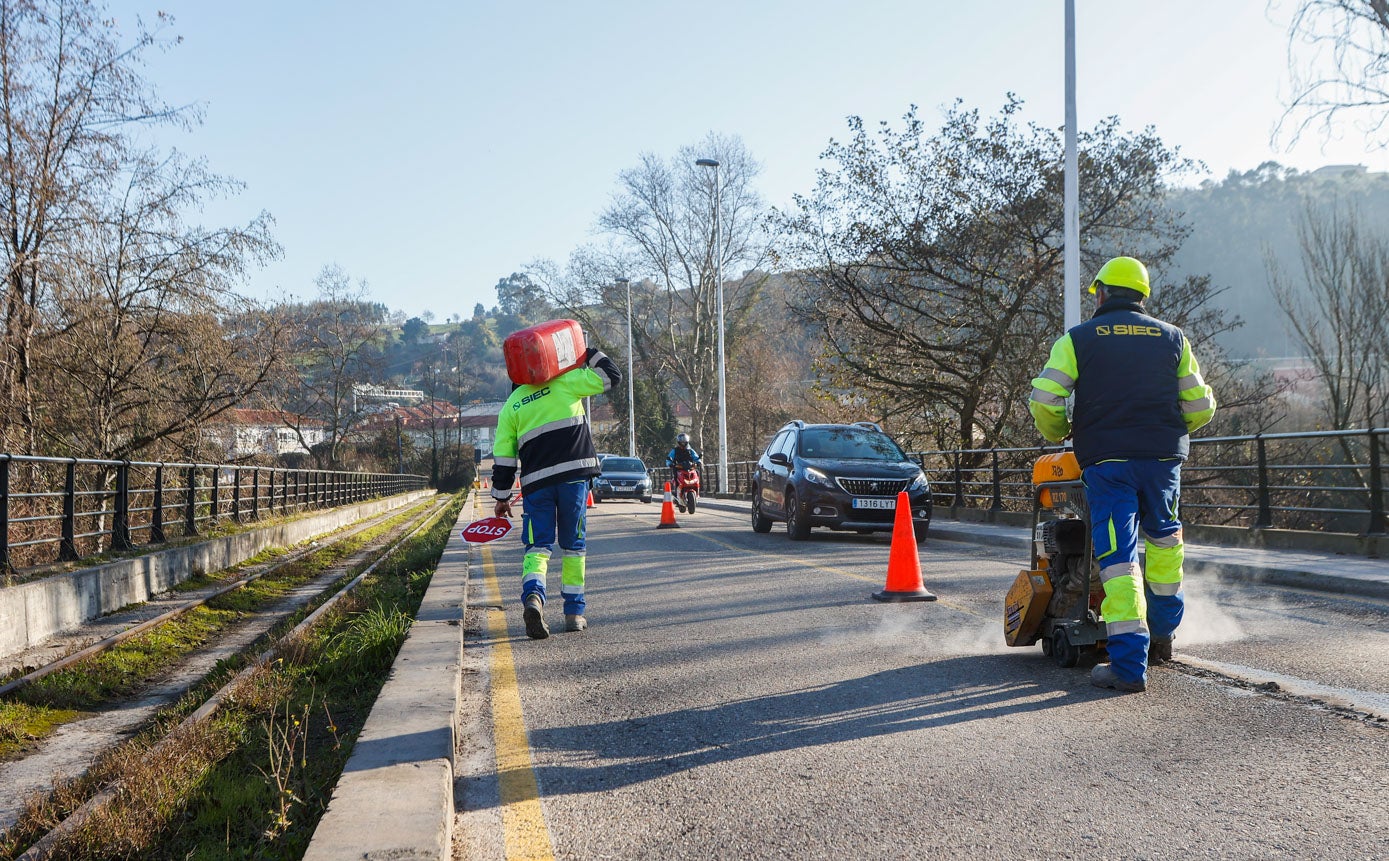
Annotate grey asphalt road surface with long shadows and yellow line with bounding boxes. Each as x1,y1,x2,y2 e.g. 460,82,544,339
454,501,1389,860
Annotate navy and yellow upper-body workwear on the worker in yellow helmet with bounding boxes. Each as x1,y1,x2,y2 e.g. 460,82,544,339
1028,300,1215,468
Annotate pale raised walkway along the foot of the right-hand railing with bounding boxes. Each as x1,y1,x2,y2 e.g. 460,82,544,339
703,499,1389,600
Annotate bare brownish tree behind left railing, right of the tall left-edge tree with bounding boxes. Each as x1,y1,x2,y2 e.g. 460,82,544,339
35,153,281,458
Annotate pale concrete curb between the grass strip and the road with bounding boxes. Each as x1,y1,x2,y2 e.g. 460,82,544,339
304,505,471,861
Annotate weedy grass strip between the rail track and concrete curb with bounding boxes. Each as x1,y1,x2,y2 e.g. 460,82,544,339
0,499,463,858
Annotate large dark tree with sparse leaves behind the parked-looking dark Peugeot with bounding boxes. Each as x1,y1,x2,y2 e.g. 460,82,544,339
774,99,1236,449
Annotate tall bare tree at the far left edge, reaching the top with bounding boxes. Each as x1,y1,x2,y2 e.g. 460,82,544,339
0,0,196,451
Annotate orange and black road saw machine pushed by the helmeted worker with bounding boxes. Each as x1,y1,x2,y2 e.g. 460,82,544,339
1003,451,1106,667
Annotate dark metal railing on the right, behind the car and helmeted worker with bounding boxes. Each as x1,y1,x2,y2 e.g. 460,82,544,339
729,428,1389,535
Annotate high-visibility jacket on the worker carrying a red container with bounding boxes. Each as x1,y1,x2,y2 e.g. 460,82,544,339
492,347,622,500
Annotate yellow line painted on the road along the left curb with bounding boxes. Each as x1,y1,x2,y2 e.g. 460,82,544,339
482,544,554,861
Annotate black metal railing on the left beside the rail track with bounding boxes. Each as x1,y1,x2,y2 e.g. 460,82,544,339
0,454,428,572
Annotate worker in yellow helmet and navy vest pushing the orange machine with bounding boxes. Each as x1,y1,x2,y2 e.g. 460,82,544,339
1028,257,1215,692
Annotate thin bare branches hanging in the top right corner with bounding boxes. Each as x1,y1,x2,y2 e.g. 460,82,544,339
1279,0,1389,147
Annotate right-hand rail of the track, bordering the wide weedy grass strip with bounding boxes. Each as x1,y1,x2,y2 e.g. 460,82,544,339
18,499,453,861
